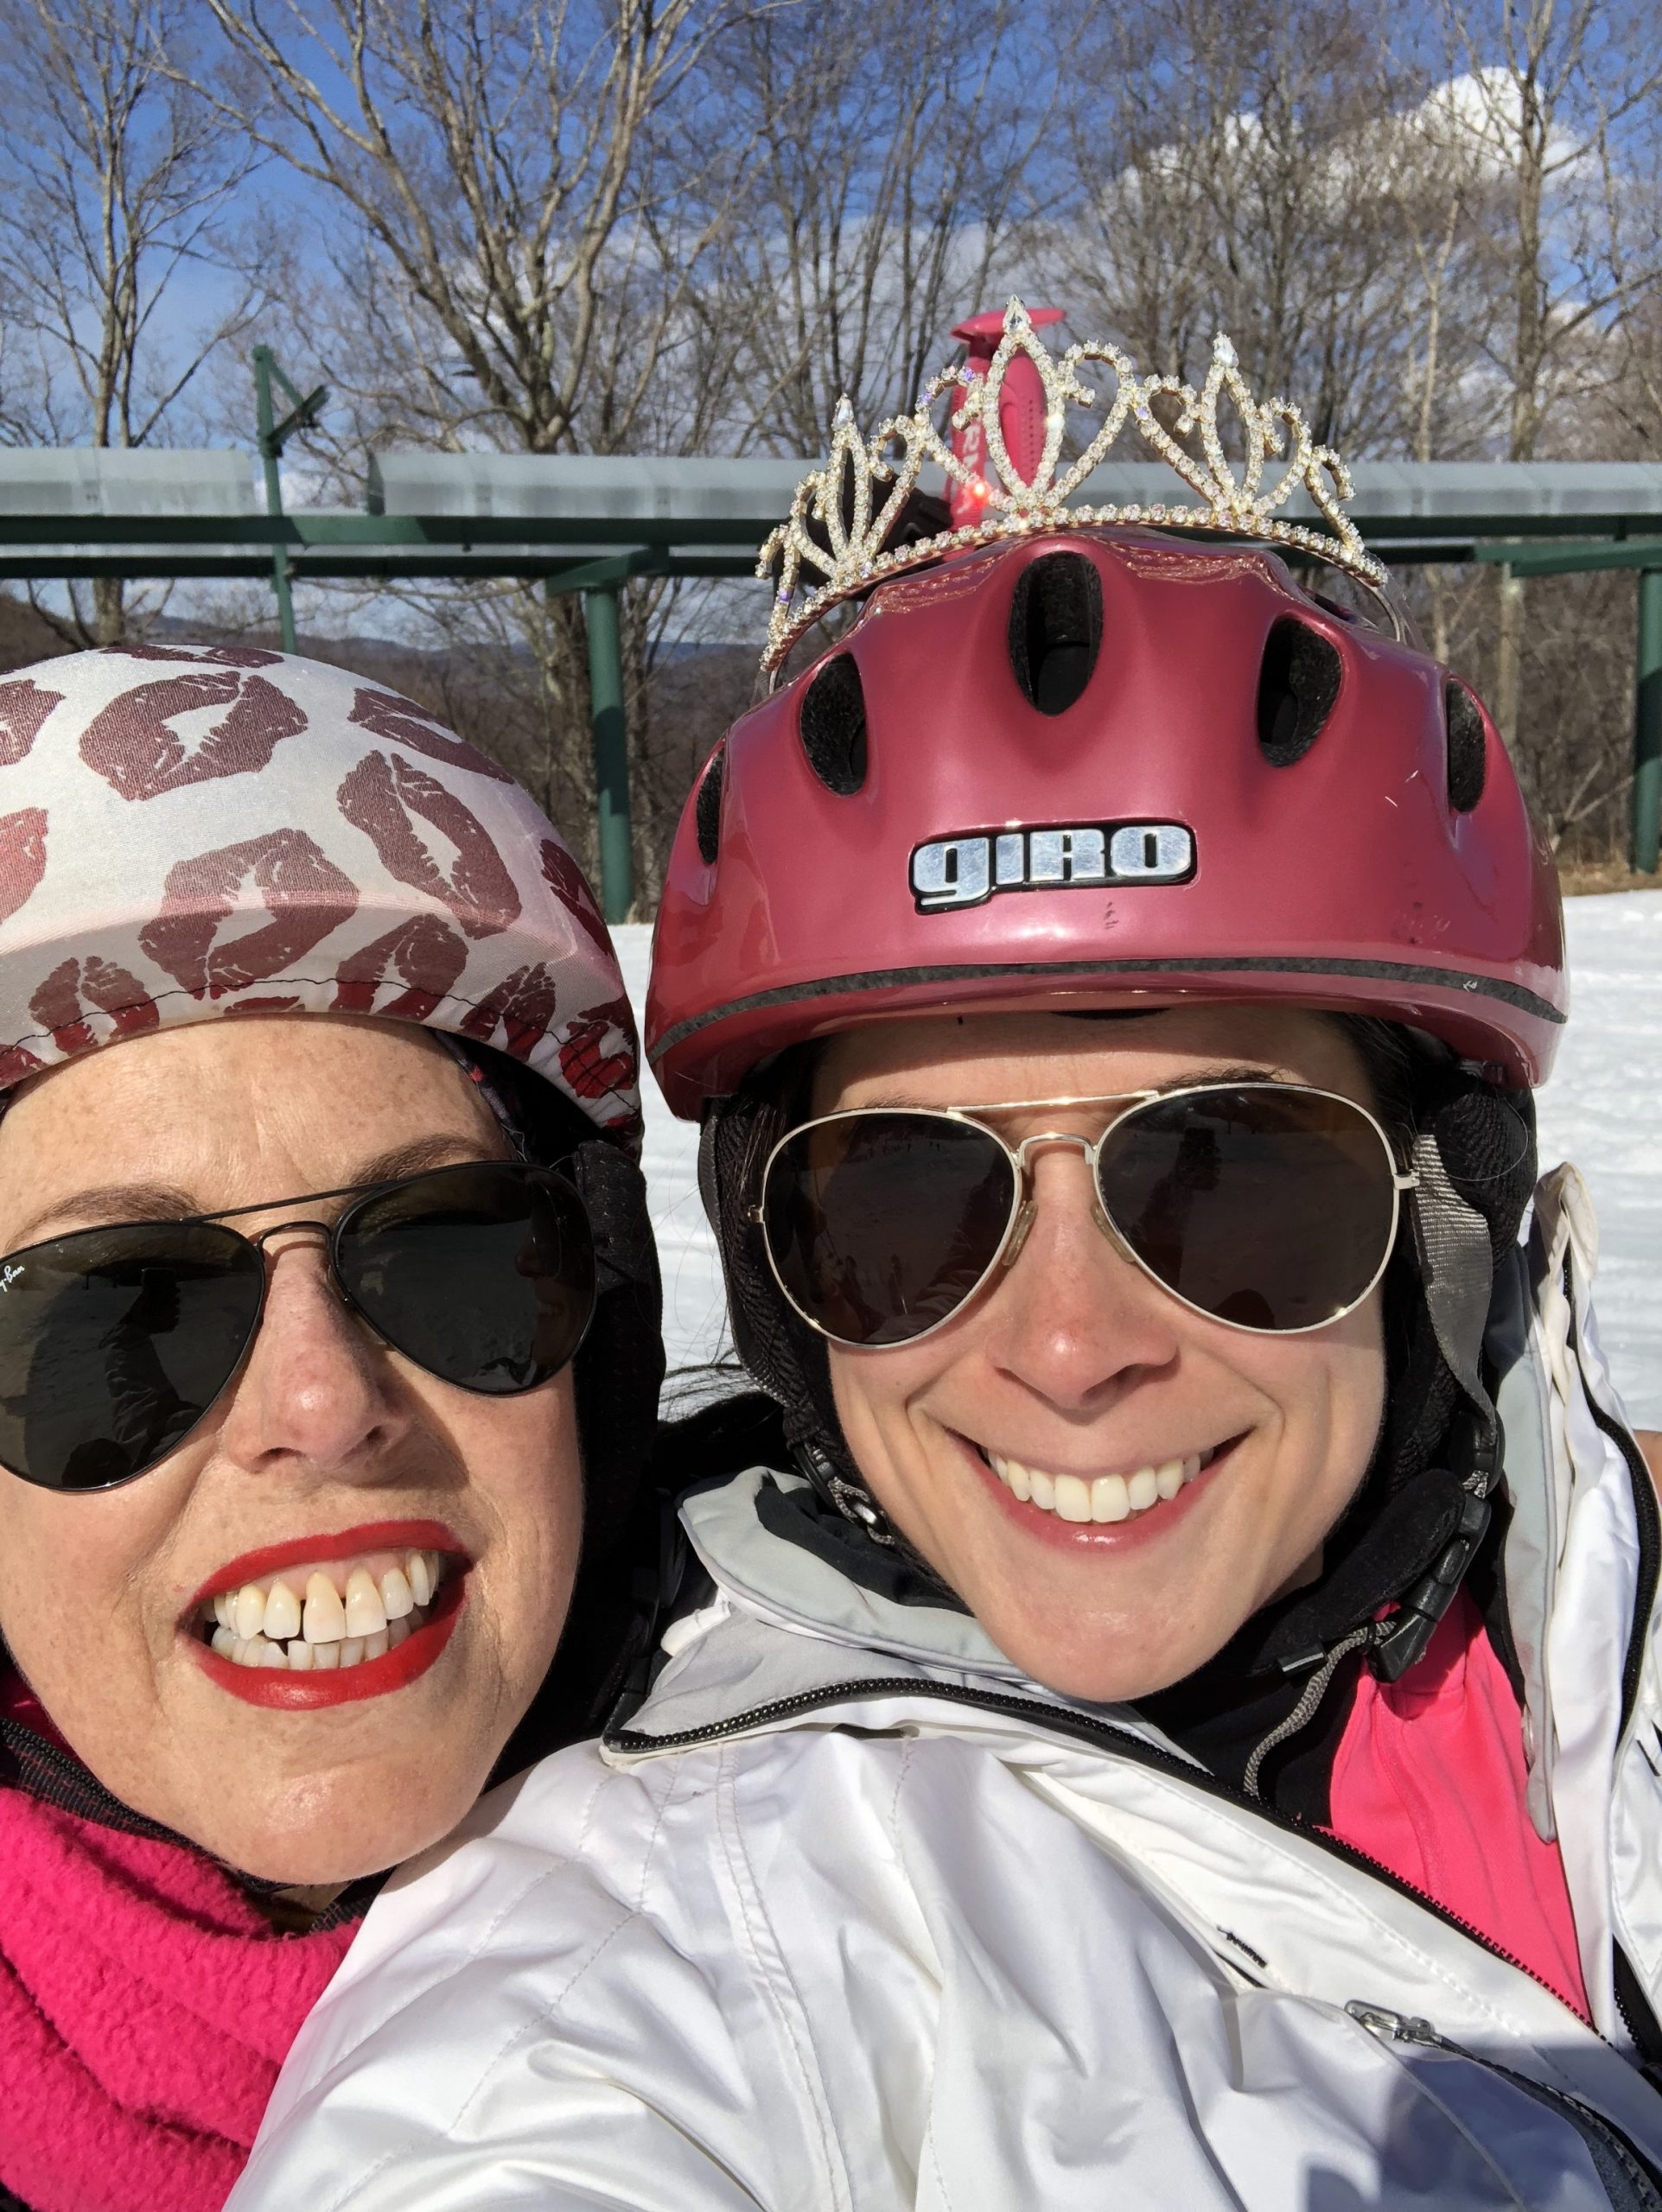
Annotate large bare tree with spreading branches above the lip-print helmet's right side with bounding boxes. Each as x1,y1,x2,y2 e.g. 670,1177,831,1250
194,0,761,906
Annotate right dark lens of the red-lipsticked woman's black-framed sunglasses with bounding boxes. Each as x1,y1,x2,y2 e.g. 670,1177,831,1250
336,1166,595,1395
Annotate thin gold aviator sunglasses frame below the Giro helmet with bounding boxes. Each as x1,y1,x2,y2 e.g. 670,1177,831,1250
748,1079,1418,1351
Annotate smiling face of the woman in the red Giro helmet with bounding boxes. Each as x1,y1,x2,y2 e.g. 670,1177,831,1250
814,1007,1385,1703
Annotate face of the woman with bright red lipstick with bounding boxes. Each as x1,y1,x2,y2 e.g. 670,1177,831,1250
0,1015,582,1885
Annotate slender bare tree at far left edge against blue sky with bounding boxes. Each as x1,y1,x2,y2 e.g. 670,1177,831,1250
0,0,257,644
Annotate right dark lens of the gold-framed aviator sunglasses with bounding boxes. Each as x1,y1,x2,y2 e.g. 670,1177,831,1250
1098,1084,1397,1330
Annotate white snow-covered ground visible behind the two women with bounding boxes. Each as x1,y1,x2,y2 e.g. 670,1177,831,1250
617,892,1662,1427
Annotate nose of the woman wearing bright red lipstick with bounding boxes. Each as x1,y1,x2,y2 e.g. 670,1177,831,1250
219,1232,410,1480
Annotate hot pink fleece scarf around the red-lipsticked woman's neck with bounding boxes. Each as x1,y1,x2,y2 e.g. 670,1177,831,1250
0,1676,354,2212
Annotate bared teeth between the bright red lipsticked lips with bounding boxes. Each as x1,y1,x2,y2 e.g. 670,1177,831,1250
193,1548,455,1675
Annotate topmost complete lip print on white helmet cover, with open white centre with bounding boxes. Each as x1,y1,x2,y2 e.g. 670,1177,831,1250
82,668,305,798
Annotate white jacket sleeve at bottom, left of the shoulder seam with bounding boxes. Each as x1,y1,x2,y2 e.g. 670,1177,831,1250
228,1745,845,2212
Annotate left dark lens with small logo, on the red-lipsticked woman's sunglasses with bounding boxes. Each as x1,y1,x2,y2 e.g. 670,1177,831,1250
0,1221,261,1491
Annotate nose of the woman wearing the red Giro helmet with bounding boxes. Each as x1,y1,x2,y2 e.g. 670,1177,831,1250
984,1146,1180,1414
